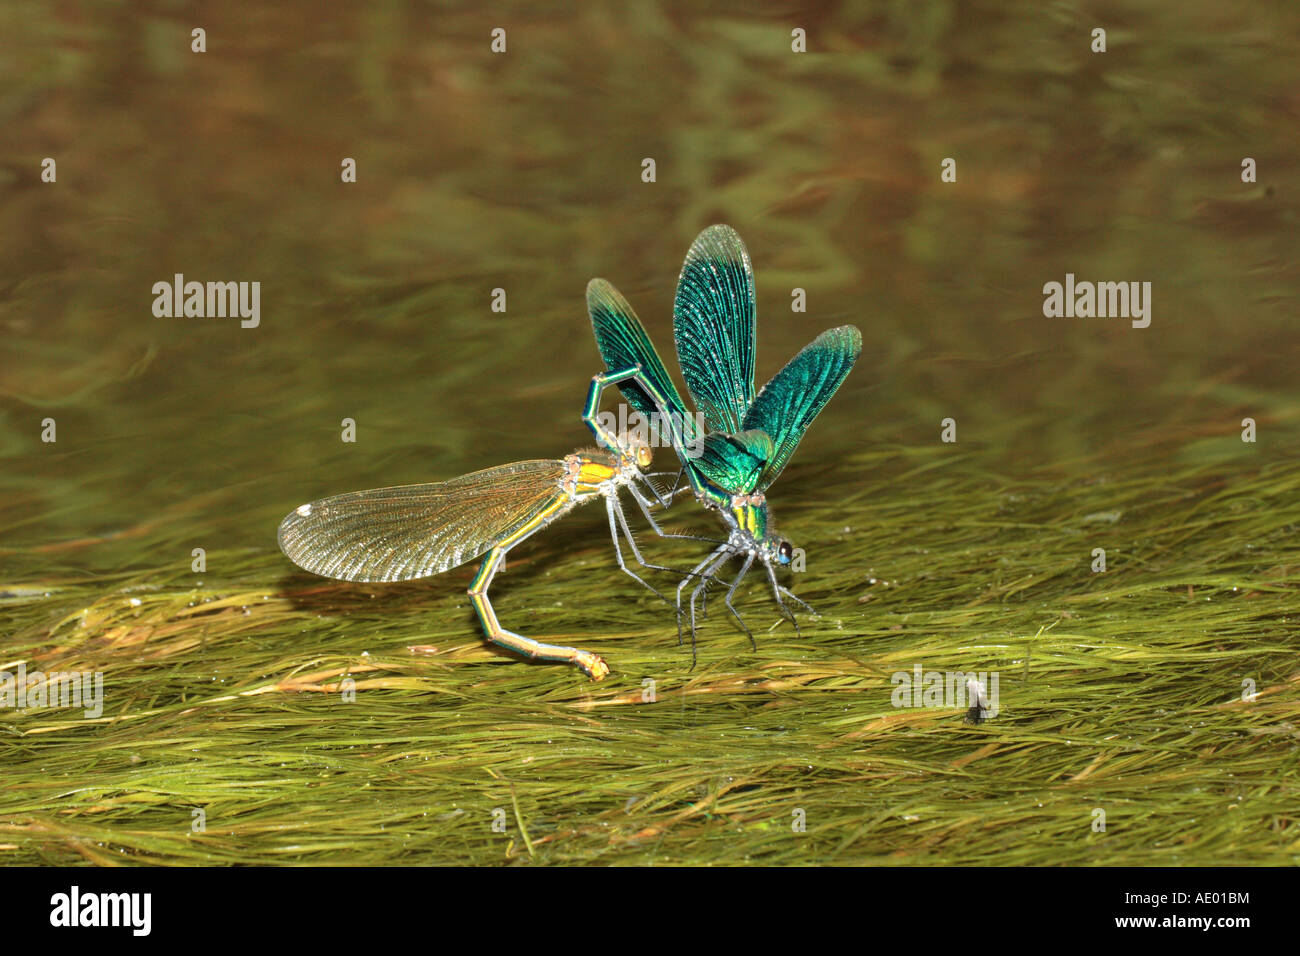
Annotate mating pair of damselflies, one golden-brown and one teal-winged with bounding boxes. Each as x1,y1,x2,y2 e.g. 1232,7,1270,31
280,225,862,680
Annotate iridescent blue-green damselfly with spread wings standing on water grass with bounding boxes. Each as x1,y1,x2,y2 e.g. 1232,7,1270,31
584,225,862,653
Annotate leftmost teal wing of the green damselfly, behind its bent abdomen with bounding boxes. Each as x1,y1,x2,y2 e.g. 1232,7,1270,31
586,278,697,441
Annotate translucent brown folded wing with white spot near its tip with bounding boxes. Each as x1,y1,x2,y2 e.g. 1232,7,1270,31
280,460,566,581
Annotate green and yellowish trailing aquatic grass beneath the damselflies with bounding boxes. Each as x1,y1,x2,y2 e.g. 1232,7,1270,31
0,421,1300,865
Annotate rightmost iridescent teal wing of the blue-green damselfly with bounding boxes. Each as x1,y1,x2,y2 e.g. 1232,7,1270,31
745,325,862,490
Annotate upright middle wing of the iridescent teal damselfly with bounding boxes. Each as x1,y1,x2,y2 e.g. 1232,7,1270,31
672,225,755,432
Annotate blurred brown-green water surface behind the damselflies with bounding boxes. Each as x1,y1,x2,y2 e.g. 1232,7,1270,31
0,3,1300,579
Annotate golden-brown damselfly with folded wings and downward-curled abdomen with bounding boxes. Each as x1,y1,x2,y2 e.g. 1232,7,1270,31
280,421,672,680
